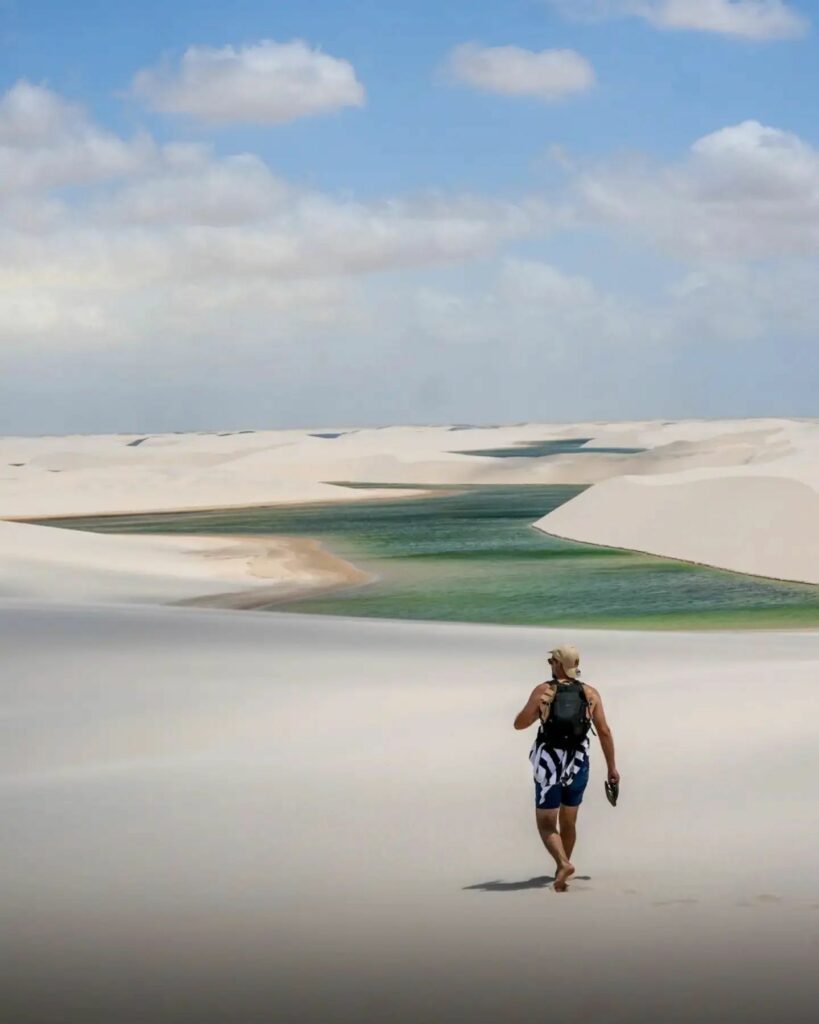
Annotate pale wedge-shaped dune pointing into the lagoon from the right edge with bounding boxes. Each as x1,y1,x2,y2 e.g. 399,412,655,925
535,422,819,584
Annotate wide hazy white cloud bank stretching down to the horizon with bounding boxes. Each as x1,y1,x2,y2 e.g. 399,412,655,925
0,84,819,430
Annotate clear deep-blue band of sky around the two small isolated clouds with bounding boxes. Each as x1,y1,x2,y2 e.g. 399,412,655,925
7,0,819,188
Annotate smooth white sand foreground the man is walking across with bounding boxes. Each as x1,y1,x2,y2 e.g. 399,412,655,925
0,603,819,1024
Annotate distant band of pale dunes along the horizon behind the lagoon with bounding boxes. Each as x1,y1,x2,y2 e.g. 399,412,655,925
0,420,819,518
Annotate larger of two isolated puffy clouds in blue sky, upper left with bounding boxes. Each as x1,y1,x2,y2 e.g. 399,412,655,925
131,40,364,124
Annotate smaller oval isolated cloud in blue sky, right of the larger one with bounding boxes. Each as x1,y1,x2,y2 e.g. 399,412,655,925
447,43,595,101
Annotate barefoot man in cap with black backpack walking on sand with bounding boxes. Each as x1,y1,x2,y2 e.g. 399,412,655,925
515,646,620,892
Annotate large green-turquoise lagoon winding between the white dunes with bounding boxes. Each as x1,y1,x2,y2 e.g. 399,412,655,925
33,484,819,629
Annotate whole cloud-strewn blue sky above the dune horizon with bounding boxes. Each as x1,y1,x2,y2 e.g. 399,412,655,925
0,0,819,434
